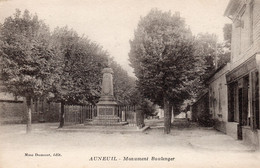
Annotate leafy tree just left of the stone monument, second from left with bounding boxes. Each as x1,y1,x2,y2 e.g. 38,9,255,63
52,27,108,127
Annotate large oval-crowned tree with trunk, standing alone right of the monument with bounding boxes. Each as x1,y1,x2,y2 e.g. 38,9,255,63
129,9,196,134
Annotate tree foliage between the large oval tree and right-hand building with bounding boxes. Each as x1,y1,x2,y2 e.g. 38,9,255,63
191,33,230,98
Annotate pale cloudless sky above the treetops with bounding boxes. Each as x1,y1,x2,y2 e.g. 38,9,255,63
0,0,231,76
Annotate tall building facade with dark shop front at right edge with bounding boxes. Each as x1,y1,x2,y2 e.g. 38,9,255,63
225,0,260,147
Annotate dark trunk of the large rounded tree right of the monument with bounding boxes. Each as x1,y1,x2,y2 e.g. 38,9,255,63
163,96,171,134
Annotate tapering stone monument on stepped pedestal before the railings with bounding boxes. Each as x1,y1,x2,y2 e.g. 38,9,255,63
93,68,124,125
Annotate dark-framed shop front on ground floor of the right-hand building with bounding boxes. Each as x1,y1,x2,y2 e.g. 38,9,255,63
226,54,260,146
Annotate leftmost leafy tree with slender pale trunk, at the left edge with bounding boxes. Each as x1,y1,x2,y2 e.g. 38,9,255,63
0,10,56,133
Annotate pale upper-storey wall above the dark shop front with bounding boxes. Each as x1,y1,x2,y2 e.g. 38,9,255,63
231,0,260,69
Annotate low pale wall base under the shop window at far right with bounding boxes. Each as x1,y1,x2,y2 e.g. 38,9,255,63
242,126,259,148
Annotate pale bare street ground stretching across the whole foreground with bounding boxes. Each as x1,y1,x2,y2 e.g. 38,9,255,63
0,119,260,168
